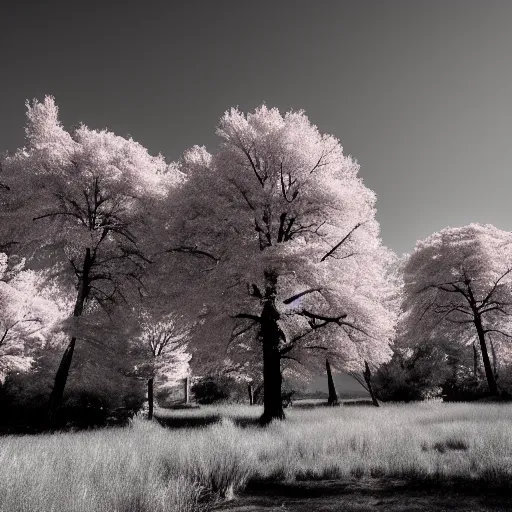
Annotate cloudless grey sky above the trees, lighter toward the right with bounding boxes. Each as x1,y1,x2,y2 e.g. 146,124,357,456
0,0,512,253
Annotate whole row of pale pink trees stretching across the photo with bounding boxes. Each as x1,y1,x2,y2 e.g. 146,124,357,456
0,97,512,428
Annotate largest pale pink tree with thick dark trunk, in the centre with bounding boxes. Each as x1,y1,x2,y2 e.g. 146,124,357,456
164,106,394,423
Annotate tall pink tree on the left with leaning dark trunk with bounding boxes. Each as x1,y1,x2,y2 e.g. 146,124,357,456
2,96,176,424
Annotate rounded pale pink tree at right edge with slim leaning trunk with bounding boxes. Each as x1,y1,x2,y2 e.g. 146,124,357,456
404,224,512,395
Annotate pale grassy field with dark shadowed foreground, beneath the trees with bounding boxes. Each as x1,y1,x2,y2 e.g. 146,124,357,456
0,403,512,512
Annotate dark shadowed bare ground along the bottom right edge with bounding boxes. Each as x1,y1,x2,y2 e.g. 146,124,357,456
215,479,512,512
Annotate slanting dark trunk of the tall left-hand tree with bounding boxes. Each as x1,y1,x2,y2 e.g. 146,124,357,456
48,248,92,426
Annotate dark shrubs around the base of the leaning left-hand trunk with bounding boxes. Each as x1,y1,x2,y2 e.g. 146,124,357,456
0,347,146,432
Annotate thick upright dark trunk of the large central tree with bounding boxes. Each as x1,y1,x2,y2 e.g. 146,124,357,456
260,271,284,425
